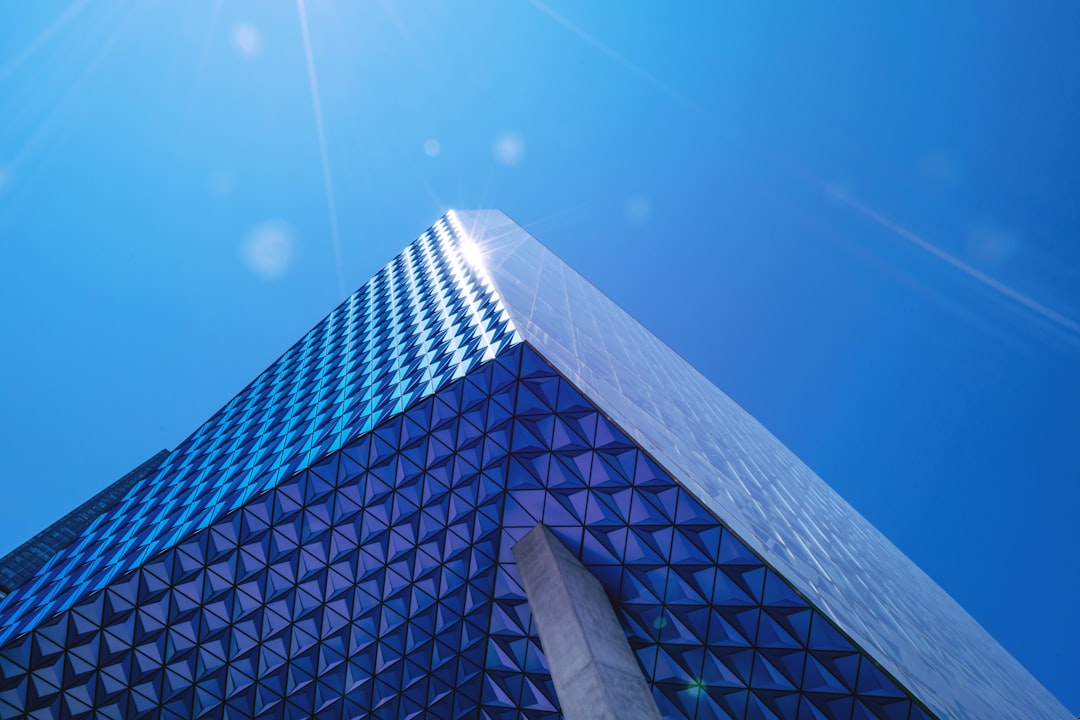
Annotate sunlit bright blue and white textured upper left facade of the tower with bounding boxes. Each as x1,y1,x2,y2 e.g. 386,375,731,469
0,218,513,643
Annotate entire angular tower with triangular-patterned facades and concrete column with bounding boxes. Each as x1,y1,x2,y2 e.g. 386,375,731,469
0,212,1070,720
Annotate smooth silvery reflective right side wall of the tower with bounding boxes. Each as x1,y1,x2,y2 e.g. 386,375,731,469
449,210,1072,720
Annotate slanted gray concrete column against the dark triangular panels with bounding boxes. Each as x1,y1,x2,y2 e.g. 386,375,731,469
513,525,660,720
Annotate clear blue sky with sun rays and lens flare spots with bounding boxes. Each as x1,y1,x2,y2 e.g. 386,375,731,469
0,0,1080,712
